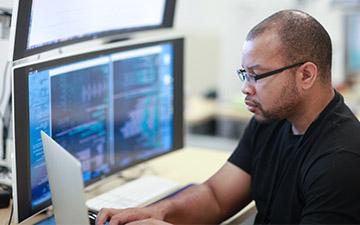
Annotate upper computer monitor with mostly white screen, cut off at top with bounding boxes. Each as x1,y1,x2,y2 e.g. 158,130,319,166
12,0,176,60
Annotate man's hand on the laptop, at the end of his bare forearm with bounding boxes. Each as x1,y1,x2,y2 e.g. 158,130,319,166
96,208,167,225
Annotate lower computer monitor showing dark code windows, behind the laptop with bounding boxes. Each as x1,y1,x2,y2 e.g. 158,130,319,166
13,38,183,222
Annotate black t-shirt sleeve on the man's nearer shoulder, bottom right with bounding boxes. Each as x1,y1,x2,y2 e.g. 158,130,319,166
301,152,360,224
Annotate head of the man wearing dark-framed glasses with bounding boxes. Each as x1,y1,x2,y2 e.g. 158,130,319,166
242,10,332,121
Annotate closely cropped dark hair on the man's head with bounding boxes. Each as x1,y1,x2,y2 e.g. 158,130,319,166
246,10,332,82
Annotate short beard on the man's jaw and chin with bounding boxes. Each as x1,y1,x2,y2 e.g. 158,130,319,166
254,76,300,123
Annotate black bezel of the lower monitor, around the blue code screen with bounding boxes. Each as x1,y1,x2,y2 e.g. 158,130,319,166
13,38,184,223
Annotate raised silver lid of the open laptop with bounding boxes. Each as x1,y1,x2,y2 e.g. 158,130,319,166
41,131,89,225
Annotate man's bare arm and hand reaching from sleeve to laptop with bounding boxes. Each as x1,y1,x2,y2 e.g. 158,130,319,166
97,162,251,225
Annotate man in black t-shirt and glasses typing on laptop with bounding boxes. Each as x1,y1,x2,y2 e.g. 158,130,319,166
97,10,360,225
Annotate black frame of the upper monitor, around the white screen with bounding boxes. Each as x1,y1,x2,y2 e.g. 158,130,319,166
12,0,176,61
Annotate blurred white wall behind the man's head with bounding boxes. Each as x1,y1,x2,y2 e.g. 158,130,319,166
175,0,350,101
